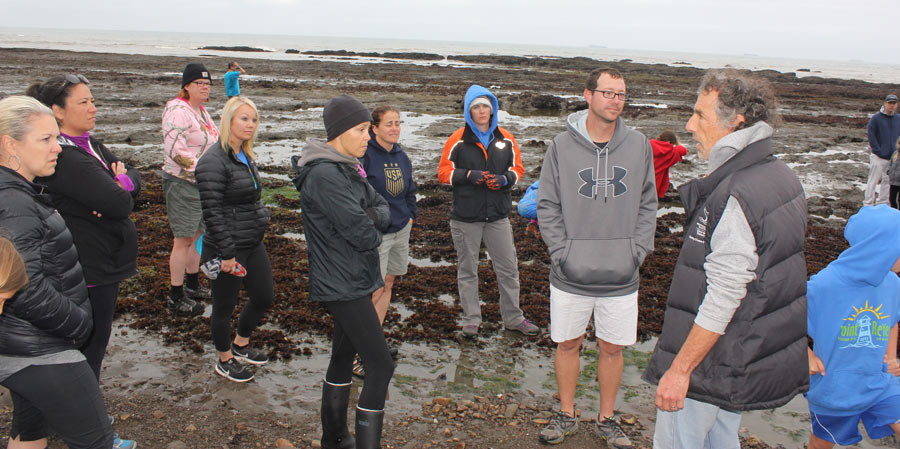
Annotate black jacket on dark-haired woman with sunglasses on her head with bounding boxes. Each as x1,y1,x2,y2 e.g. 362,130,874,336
35,138,141,285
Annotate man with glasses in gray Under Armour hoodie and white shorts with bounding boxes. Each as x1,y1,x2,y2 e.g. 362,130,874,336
537,68,657,448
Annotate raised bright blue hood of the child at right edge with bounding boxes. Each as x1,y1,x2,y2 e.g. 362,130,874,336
828,204,900,286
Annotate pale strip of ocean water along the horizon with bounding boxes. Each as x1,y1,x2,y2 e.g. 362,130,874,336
0,27,900,83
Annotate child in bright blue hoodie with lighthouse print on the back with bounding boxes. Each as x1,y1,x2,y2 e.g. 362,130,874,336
806,204,900,449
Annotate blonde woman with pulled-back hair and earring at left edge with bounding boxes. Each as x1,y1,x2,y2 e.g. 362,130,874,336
0,96,137,449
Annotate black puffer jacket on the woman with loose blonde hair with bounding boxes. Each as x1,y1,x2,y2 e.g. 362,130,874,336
194,141,270,259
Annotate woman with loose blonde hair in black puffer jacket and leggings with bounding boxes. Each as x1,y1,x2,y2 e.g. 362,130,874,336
195,95,275,382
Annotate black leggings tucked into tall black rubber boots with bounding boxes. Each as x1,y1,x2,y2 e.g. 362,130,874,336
324,296,394,410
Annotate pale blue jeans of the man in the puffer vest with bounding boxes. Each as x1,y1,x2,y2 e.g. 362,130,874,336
653,399,741,449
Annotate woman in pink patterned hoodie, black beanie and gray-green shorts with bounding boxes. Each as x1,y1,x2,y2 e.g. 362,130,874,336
162,62,219,315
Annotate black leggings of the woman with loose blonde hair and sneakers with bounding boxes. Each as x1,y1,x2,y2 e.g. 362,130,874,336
210,243,275,352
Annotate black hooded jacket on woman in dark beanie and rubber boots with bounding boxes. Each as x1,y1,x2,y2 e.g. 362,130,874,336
292,139,391,301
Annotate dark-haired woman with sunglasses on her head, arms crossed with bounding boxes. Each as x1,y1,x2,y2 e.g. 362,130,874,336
26,74,141,380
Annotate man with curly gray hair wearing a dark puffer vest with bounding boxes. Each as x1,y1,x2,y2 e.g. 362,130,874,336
644,70,809,449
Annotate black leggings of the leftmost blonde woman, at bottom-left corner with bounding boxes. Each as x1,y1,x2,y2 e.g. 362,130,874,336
0,361,113,449
